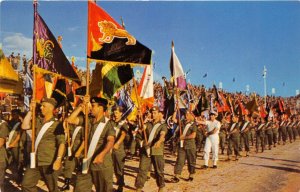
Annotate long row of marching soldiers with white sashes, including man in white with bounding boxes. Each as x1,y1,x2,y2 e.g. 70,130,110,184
0,89,300,191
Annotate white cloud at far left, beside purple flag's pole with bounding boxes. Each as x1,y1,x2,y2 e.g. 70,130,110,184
2,33,32,57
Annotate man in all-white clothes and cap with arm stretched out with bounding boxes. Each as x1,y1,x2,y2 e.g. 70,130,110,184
198,111,221,169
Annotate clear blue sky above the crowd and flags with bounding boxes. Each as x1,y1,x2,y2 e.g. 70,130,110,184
0,1,300,96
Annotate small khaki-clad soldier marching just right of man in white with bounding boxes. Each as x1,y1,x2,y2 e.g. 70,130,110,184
227,116,240,160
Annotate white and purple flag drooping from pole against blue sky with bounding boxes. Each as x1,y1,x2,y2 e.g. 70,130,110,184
170,41,186,89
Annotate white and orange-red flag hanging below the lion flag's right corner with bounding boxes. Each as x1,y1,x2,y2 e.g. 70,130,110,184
138,65,154,112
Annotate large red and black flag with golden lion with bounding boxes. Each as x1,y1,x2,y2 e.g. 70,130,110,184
87,1,152,64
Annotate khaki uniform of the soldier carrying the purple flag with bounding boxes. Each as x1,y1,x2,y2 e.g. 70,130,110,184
22,117,65,192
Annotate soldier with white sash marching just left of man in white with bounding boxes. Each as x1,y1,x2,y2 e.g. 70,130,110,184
172,111,197,183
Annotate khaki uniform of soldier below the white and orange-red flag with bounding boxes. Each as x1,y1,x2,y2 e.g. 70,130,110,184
135,123,168,189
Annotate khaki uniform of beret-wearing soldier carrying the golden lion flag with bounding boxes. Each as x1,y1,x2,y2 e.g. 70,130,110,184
75,117,115,192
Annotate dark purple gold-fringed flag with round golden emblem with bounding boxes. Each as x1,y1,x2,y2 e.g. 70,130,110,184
33,11,79,81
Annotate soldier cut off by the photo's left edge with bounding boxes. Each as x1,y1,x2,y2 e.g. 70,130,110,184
0,113,9,191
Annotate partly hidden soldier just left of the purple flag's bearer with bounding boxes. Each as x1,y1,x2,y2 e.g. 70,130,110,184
6,109,24,183
